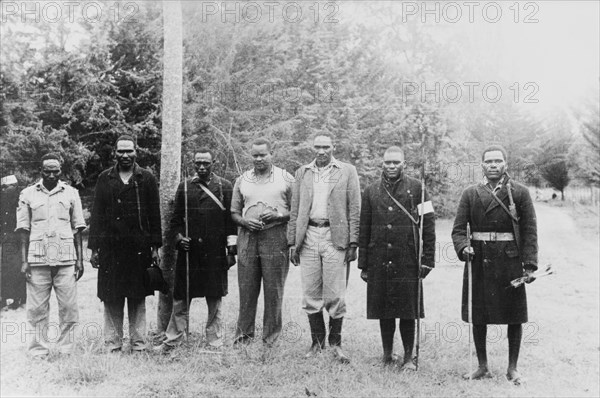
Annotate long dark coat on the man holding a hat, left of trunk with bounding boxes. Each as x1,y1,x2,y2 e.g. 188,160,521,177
88,164,162,301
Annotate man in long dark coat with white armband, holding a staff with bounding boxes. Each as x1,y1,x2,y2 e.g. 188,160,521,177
358,146,435,370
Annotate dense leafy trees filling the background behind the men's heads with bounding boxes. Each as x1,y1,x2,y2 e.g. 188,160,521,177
0,2,599,214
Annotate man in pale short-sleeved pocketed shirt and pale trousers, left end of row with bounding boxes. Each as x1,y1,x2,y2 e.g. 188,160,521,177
16,154,85,359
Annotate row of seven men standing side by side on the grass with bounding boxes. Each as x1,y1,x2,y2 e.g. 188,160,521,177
9,135,537,382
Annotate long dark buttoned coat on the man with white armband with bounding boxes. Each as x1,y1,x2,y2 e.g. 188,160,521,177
358,176,435,319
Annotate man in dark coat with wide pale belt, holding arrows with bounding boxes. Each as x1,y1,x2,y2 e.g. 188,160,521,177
452,146,538,384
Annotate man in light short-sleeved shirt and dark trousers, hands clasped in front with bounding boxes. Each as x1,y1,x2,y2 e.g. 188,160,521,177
231,138,293,350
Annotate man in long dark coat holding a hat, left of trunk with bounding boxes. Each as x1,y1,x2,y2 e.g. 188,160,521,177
88,135,162,352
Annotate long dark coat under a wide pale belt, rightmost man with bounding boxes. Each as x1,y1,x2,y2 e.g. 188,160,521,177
452,176,538,325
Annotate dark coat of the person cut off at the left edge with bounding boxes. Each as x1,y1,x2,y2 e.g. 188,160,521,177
0,185,27,304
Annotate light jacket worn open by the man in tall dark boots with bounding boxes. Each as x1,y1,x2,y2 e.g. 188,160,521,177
287,159,360,249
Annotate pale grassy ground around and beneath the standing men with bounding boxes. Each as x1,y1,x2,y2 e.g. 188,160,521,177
0,203,600,397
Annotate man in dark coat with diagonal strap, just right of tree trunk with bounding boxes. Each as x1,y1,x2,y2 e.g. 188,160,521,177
156,148,237,351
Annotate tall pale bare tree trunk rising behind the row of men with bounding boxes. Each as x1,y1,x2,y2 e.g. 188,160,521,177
156,0,183,333
